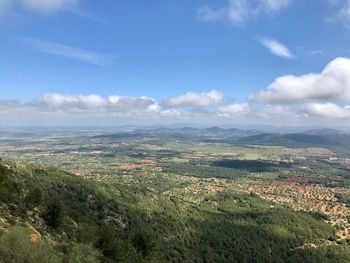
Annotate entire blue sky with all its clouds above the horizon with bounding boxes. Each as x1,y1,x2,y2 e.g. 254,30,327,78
0,0,350,127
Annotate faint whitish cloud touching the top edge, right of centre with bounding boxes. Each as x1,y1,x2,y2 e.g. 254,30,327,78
197,0,292,25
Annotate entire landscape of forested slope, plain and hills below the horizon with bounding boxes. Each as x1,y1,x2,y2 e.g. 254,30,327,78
0,127,350,262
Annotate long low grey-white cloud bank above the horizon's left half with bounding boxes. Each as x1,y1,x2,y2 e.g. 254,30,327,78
0,93,193,125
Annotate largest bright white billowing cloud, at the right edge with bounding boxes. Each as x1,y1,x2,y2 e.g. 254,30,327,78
250,58,350,104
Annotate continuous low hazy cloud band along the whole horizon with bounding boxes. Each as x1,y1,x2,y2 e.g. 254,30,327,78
0,93,350,125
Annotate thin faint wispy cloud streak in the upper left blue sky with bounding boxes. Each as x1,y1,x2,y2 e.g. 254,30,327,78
18,37,115,67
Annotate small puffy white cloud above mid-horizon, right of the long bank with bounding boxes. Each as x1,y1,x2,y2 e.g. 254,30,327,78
163,90,224,107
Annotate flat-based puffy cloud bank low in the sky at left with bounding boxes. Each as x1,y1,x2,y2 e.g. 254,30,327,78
16,93,186,123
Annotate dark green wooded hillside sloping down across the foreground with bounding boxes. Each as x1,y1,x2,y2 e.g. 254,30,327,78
0,161,350,263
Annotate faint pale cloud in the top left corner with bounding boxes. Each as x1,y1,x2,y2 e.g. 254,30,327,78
0,0,79,15
